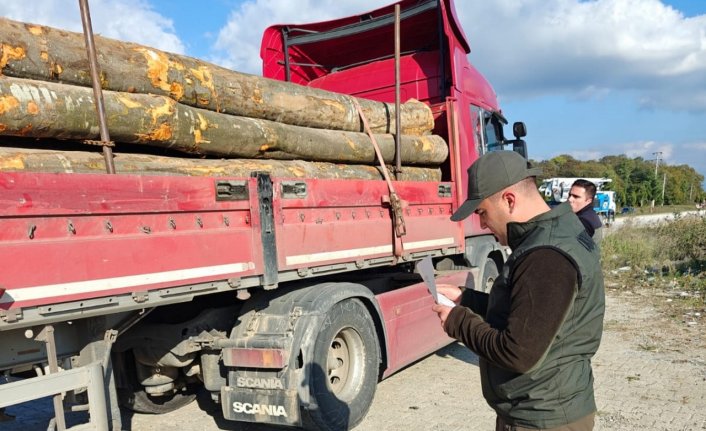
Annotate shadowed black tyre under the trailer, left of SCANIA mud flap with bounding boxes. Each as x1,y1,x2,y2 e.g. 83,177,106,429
115,351,197,415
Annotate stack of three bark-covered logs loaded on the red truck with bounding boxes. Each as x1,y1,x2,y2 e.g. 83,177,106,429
0,18,448,181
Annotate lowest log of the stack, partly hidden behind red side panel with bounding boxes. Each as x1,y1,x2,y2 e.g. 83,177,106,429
0,146,441,181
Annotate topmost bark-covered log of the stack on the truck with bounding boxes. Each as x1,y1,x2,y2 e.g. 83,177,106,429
0,18,434,135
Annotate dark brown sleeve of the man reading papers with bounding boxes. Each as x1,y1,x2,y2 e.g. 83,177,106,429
445,248,578,373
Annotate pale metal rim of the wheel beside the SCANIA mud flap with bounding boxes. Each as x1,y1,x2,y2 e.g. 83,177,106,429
327,328,365,399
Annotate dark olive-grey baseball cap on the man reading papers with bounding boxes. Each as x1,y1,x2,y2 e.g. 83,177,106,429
451,151,542,221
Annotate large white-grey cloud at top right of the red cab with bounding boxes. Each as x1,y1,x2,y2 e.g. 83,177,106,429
456,0,706,111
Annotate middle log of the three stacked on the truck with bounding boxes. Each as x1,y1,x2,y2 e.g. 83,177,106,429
0,76,448,166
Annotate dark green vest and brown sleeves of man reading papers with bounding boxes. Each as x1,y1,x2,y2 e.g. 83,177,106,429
445,204,605,428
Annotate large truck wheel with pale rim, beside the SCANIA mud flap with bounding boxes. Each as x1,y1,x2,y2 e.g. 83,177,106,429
303,299,380,431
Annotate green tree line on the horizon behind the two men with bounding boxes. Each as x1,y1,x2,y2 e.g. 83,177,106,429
531,154,706,207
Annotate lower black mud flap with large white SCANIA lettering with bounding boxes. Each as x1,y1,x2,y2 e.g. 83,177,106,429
221,386,301,426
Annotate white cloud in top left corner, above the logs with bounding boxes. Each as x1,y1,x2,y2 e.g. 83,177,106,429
0,0,184,53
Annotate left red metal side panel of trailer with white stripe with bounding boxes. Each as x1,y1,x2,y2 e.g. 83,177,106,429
0,173,263,323
